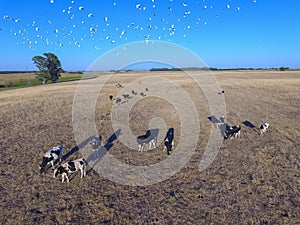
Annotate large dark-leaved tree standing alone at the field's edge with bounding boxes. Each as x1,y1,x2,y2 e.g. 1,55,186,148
32,53,63,84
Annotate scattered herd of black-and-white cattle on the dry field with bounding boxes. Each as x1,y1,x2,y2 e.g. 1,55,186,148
40,84,269,183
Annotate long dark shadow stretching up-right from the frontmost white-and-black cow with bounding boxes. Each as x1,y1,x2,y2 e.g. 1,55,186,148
85,129,121,174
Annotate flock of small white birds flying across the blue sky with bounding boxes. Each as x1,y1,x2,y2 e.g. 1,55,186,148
0,0,256,50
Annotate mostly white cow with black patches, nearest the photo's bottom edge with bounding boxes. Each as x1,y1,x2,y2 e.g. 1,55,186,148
53,158,86,183
